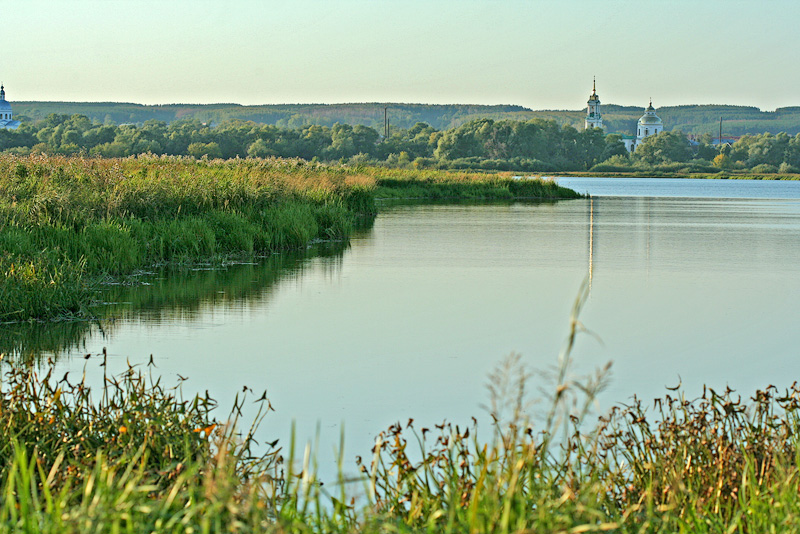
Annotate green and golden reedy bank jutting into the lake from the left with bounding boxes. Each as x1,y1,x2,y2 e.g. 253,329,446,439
0,156,577,323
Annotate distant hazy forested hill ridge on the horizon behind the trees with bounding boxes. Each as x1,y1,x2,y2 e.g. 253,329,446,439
12,102,800,135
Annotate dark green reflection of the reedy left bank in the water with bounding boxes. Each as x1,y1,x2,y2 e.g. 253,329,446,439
0,242,348,361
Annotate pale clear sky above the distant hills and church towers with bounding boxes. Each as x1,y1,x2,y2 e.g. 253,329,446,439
0,0,800,110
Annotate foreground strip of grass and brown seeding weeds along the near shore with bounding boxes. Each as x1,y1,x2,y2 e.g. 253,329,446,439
0,348,800,534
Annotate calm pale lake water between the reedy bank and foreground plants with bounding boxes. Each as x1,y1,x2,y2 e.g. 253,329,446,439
6,178,800,480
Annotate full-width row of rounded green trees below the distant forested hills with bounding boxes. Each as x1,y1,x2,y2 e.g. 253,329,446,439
0,114,800,173
